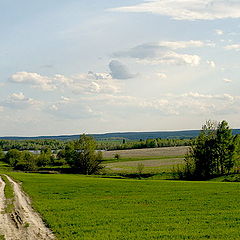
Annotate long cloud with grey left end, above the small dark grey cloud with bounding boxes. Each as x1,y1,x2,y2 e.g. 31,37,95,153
114,40,205,66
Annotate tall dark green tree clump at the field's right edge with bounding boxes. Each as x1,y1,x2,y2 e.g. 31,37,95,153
185,121,239,179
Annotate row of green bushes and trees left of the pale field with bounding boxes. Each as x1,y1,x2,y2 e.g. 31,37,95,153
0,135,102,174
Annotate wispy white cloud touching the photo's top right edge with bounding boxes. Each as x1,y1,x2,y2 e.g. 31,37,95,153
110,0,240,20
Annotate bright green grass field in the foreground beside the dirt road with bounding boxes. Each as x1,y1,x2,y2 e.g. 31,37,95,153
5,173,240,240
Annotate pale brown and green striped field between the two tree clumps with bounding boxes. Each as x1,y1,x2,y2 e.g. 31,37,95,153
103,147,188,174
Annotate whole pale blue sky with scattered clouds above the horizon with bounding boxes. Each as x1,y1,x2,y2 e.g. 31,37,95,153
0,0,240,136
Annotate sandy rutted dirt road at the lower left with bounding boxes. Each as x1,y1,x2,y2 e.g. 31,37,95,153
0,176,55,240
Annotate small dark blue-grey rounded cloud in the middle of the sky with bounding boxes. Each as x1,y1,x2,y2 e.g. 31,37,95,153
109,60,135,79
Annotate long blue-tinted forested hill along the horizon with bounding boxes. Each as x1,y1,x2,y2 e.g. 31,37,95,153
0,129,240,141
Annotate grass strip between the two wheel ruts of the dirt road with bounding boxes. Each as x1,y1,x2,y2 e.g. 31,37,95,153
1,175,14,213
